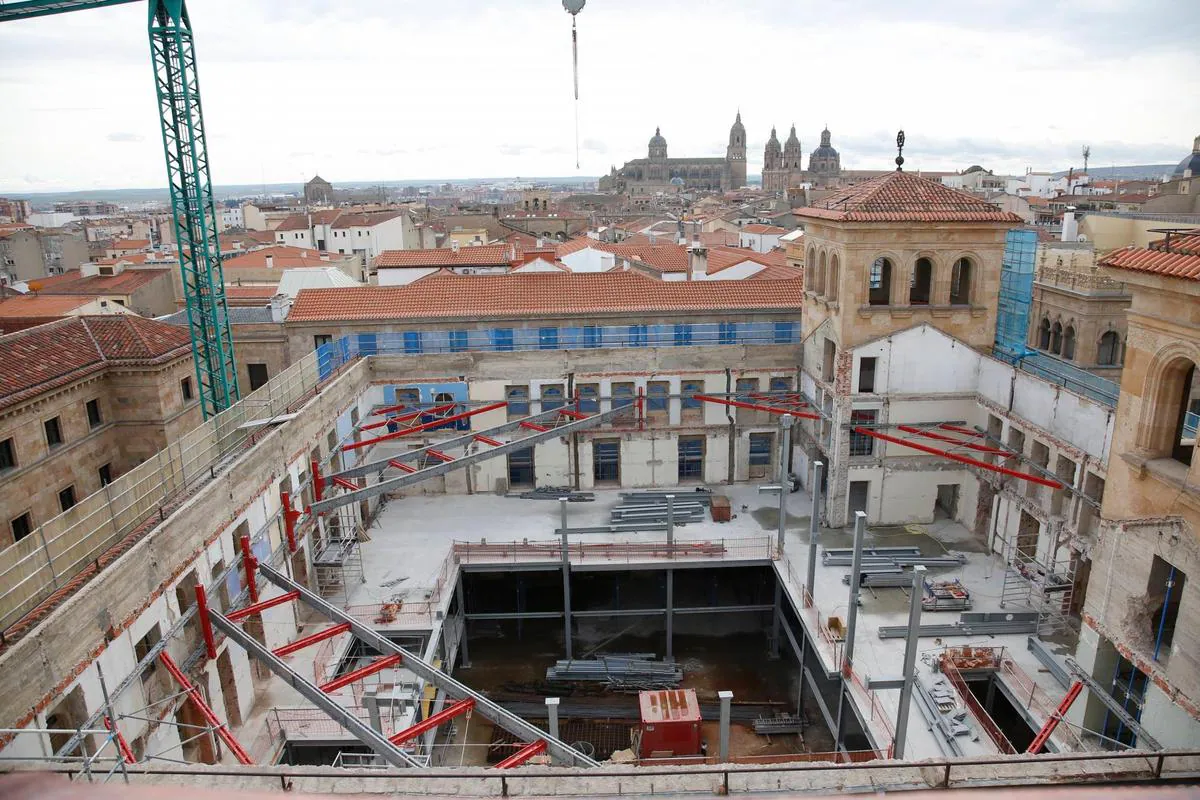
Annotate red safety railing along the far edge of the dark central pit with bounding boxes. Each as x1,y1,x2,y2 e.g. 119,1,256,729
452,536,774,564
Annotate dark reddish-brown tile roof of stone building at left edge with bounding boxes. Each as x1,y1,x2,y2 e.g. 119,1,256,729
0,314,192,409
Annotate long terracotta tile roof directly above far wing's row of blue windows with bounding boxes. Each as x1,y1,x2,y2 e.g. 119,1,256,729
288,271,800,324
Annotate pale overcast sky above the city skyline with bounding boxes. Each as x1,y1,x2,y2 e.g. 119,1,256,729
0,0,1200,193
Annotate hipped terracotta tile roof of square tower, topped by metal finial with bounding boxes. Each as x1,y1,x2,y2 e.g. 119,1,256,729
796,172,1021,221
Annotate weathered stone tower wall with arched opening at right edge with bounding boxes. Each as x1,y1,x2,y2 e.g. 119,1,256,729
1079,256,1200,747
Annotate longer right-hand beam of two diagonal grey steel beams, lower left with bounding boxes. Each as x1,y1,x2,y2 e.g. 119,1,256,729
258,564,599,766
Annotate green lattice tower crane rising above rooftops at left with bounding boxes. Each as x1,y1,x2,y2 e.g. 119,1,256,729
0,0,239,419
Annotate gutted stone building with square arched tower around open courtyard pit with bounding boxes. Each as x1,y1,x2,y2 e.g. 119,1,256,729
0,172,1200,795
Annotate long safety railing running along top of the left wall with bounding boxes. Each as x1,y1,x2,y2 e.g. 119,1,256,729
0,348,356,643
